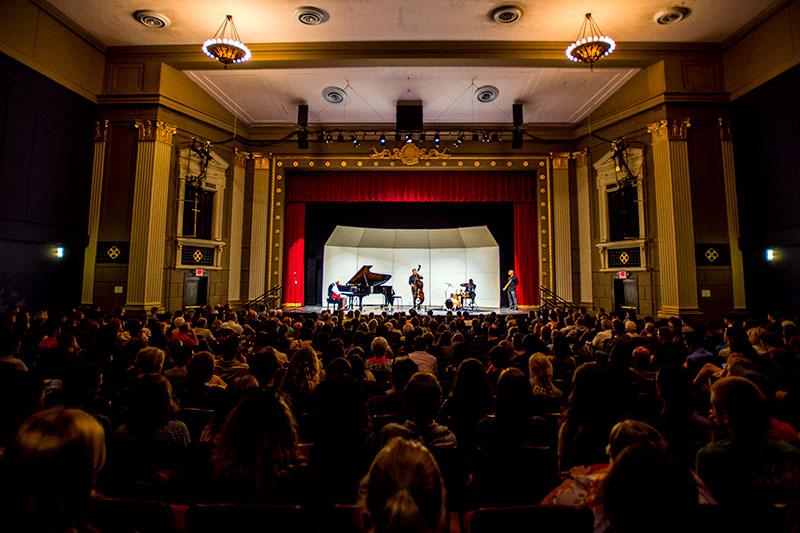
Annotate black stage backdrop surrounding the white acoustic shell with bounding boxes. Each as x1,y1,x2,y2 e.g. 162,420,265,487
305,202,514,305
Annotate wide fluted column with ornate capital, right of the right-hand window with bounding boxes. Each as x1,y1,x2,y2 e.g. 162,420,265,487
647,118,700,317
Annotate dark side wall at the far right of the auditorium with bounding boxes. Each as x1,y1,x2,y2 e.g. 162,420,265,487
733,62,800,312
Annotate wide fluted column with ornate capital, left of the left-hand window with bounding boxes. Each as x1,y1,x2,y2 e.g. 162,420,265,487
125,120,177,310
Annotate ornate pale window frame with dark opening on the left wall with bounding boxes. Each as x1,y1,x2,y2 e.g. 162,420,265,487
175,148,230,270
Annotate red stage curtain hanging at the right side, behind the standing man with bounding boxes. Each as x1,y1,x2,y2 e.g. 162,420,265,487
503,202,540,305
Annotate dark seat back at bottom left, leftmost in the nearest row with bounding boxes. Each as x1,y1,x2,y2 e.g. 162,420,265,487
89,498,176,533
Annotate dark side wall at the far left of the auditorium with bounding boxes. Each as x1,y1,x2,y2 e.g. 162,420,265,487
0,54,95,310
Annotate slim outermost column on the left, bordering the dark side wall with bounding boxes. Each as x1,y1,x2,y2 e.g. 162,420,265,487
81,120,108,305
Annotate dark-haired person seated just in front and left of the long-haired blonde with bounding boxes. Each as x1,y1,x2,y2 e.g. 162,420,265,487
477,368,549,449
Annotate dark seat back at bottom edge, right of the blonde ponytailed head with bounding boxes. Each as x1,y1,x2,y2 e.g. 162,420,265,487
469,505,594,533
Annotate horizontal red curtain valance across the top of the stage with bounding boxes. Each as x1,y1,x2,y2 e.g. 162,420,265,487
286,171,536,202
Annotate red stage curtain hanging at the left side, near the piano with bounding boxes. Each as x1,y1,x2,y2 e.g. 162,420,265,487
283,202,306,305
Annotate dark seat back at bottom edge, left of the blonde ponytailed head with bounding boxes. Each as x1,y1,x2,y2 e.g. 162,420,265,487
186,503,315,533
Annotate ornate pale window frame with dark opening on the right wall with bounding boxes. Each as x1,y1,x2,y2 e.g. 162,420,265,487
593,148,647,272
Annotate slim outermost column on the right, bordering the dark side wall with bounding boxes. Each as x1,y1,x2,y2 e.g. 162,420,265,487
719,118,747,310
